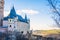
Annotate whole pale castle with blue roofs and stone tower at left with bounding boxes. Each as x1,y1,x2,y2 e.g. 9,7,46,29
0,0,30,34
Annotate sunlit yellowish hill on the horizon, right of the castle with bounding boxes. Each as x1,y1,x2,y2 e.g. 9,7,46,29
32,29,60,36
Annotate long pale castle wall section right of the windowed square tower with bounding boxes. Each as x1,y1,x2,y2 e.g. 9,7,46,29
17,22,29,34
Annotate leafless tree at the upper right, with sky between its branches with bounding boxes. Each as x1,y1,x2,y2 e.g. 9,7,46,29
47,0,60,27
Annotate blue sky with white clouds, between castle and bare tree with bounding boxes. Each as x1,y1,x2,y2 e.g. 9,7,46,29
4,0,59,30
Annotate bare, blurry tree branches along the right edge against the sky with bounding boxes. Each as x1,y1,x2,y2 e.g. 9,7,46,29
47,0,60,27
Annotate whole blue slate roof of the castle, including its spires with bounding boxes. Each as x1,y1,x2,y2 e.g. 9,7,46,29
3,7,28,23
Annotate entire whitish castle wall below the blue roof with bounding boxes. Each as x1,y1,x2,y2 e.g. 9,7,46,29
3,21,30,34
